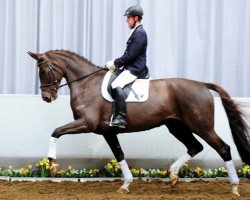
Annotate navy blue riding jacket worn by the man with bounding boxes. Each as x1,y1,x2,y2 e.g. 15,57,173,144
114,25,148,78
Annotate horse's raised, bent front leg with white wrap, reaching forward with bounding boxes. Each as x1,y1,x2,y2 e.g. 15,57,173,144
48,119,91,176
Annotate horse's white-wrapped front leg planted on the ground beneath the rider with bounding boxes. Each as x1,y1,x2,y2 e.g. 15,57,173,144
103,133,133,192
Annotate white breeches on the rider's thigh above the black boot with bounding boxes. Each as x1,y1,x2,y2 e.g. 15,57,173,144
111,70,137,89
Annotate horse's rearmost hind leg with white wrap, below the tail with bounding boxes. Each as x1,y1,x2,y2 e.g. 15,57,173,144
199,130,239,195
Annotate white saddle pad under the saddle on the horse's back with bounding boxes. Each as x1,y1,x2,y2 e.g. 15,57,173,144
102,70,150,102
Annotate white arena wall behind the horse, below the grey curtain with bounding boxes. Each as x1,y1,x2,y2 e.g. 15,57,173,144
0,95,250,169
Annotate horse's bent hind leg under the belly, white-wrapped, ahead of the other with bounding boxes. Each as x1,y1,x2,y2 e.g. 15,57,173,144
166,120,203,187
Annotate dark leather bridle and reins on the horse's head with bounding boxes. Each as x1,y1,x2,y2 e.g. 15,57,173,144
37,54,107,96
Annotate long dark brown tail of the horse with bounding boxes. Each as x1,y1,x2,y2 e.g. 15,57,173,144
205,83,250,165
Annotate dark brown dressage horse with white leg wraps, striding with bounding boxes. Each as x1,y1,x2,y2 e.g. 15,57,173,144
28,50,250,195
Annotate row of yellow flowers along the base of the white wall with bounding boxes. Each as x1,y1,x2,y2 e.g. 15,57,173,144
0,158,250,178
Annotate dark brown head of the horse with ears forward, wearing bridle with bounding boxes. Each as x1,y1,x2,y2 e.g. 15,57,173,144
28,52,63,103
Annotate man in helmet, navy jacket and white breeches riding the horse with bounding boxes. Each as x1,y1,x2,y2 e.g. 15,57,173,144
106,5,148,128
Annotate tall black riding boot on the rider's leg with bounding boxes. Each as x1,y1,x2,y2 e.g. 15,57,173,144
111,87,127,128
